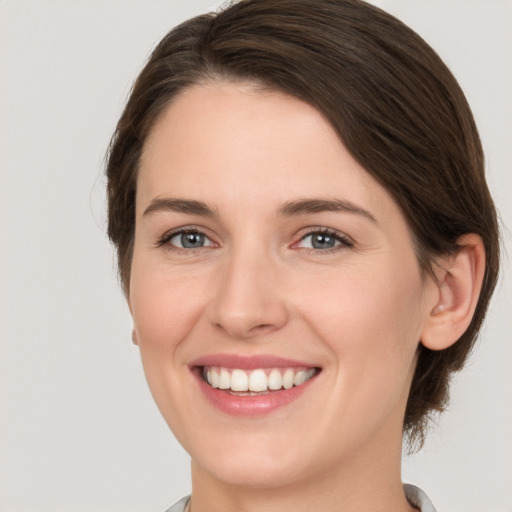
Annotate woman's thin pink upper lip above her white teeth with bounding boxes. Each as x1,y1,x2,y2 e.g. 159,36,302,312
190,354,318,370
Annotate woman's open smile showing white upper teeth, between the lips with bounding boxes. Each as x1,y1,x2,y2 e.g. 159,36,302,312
199,366,320,396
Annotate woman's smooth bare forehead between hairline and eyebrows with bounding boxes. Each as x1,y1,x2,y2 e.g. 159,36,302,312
137,82,396,220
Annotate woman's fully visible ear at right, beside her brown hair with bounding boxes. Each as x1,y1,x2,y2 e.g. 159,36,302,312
421,233,485,350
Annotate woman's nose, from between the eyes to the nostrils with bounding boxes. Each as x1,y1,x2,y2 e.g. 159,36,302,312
210,251,288,339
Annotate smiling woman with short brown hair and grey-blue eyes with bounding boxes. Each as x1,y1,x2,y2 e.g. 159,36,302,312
107,0,499,512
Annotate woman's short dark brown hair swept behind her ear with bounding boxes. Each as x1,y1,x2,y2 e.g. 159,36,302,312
106,0,499,445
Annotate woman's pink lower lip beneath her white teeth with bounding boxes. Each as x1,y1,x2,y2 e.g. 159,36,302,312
193,371,317,416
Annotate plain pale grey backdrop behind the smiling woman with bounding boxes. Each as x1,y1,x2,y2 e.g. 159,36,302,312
0,0,512,512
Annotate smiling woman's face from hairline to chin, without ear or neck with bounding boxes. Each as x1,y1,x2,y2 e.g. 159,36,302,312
129,83,436,486
